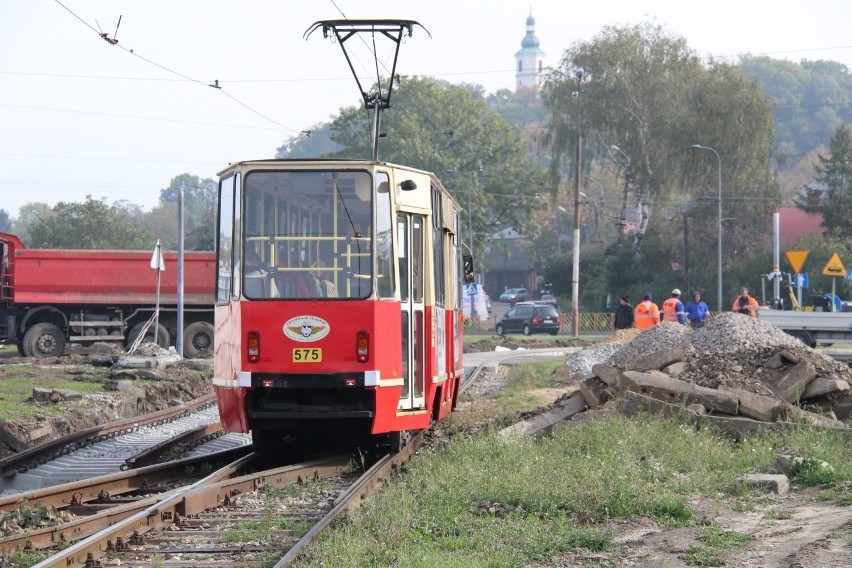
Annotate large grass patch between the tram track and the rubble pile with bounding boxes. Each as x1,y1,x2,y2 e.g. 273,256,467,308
292,394,852,567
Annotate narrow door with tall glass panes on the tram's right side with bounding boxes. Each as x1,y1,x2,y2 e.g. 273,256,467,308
397,213,426,410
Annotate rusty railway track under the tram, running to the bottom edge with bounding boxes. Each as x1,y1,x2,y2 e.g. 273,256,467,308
0,432,424,568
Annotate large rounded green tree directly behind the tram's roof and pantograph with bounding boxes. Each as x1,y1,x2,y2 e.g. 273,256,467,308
302,77,549,253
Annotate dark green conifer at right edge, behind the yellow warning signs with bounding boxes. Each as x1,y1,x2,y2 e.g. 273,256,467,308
802,124,852,235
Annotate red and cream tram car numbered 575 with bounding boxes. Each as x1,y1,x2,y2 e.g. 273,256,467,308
213,160,470,450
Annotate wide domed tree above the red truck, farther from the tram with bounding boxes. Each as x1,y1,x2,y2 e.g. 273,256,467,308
28,195,154,250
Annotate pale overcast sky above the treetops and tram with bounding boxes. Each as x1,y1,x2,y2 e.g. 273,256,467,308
0,0,852,217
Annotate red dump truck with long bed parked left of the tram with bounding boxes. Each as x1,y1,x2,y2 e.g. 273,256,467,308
0,233,216,357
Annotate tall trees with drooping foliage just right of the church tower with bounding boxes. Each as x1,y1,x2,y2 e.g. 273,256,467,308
543,24,779,308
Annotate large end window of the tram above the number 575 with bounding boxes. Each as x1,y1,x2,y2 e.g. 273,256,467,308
241,170,373,299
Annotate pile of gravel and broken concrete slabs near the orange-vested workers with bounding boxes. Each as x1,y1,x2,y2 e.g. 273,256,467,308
568,313,852,427
